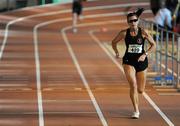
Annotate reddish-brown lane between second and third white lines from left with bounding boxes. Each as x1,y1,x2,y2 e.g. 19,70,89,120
35,20,100,125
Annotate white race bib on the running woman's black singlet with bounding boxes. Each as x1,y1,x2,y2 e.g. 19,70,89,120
128,44,142,53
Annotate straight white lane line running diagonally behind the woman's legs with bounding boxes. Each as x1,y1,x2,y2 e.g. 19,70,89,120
87,28,174,126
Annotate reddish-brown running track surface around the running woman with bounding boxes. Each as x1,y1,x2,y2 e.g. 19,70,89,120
0,0,180,126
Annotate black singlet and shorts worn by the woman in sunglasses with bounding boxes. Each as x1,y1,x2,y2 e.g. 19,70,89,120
123,28,148,72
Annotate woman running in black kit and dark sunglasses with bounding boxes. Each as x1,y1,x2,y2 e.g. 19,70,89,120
112,8,156,119
